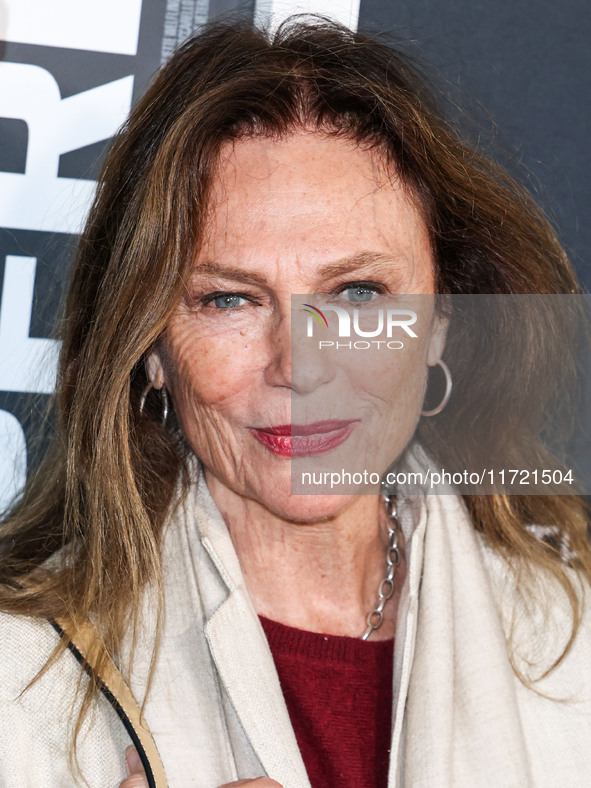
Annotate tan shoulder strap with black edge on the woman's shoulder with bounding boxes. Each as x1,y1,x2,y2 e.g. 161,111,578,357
51,619,167,788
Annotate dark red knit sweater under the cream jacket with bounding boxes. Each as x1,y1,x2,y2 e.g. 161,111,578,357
261,616,394,788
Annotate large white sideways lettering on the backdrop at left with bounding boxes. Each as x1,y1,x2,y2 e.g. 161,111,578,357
0,9,142,502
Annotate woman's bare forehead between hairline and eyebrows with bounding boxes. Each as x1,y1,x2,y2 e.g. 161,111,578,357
199,132,431,286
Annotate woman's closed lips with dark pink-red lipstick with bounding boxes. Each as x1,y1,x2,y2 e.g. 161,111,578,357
251,419,359,457
